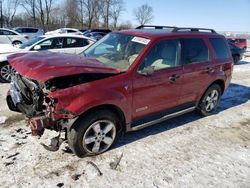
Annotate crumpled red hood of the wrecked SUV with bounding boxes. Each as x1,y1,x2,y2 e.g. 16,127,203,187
8,52,120,82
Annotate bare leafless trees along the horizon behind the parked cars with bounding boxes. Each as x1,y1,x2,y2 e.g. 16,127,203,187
0,0,153,31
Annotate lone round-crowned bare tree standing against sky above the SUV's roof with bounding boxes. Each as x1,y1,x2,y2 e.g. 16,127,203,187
134,4,154,25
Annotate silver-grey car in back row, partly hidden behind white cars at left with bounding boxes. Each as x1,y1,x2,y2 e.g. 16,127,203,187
13,27,44,38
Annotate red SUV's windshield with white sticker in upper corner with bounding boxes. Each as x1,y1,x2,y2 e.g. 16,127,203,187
84,33,150,72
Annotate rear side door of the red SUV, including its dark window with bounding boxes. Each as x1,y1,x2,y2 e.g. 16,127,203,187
180,37,214,104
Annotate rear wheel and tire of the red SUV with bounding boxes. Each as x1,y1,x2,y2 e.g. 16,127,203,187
198,84,221,116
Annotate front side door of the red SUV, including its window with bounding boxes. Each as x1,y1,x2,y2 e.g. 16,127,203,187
132,39,182,120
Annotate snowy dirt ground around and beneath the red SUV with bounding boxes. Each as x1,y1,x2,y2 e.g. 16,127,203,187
0,58,250,188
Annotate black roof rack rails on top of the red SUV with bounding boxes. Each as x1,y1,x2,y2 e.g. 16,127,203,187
136,25,216,33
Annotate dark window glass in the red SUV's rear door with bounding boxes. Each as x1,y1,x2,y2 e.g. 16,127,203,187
181,38,209,64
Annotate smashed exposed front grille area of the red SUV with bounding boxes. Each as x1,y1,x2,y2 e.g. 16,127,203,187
10,74,44,117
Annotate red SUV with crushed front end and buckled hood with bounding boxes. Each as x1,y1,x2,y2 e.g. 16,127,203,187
7,26,233,157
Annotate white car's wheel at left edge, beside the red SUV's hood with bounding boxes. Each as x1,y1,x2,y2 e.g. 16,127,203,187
0,62,16,83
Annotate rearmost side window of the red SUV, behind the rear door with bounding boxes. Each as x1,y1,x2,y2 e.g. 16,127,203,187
209,38,230,59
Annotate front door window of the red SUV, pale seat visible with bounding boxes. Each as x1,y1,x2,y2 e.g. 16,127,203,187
139,40,179,70
